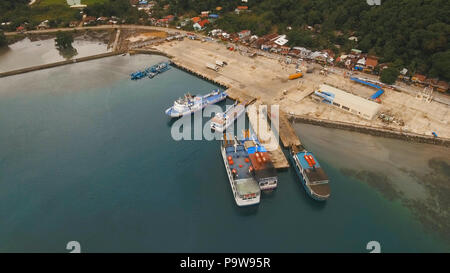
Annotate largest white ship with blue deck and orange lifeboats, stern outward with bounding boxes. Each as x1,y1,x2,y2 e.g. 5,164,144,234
221,135,261,207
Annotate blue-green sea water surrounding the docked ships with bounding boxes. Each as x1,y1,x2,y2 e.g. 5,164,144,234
0,56,449,252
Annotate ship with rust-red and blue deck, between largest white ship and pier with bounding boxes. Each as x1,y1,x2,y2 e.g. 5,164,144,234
243,130,278,192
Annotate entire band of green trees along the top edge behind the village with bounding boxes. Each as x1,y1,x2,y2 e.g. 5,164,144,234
0,0,450,81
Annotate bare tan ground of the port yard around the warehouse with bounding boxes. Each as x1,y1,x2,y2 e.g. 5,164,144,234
156,39,450,138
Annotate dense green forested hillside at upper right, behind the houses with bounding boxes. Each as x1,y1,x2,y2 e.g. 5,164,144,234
156,0,450,80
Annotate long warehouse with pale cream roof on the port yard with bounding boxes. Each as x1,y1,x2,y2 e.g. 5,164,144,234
313,84,381,120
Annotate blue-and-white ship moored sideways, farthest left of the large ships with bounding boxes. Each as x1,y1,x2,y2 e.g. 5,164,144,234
166,89,227,118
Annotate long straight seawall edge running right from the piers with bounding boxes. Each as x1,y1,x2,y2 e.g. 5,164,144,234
288,115,450,147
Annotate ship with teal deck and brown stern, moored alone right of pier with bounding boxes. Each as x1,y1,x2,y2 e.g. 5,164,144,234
290,145,331,201
